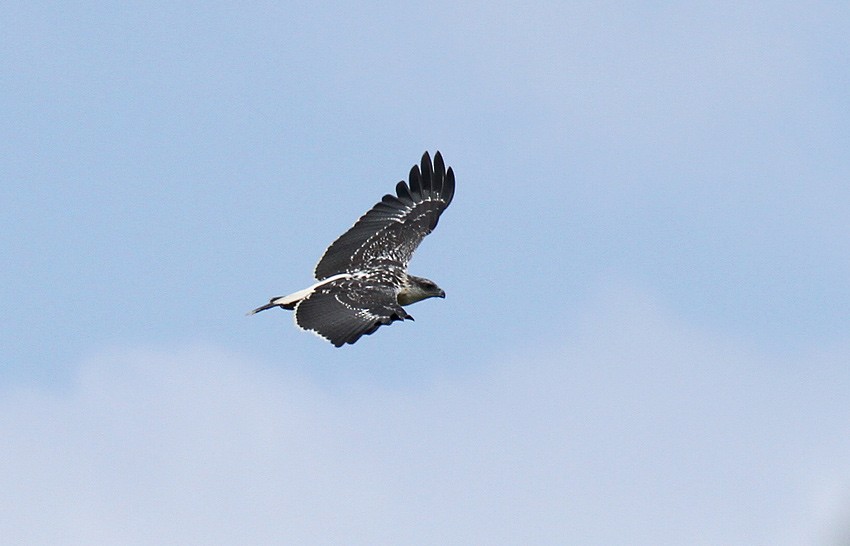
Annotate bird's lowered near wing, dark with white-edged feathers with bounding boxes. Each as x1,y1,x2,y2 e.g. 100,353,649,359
295,277,413,347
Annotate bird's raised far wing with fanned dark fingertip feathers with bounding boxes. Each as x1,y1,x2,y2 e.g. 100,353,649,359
315,152,455,280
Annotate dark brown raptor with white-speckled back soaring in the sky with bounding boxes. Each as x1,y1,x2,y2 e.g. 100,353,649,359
248,152,455,347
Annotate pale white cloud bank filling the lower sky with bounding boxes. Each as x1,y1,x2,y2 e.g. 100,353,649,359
0,291,850,545
